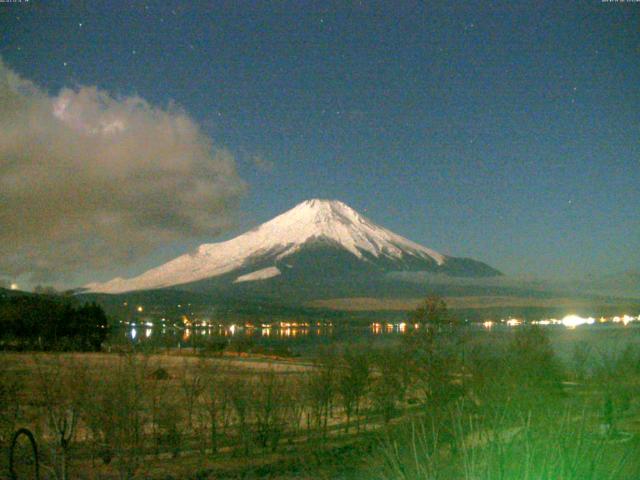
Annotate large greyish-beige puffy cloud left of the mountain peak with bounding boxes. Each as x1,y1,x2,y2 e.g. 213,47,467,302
0,60,246,281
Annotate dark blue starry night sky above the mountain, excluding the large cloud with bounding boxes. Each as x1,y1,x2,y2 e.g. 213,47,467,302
0,0,640,288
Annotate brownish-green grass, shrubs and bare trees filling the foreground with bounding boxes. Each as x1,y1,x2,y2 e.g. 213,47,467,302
0,299,640,480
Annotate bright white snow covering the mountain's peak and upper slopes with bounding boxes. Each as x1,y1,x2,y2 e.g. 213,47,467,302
85,199,448,293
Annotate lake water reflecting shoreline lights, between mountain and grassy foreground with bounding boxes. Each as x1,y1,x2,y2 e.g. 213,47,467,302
110,321,640,361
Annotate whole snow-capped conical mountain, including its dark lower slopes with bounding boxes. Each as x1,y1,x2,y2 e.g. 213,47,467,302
85,199,502,297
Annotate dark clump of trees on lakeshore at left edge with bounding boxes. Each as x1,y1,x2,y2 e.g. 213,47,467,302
0,295,108,351
